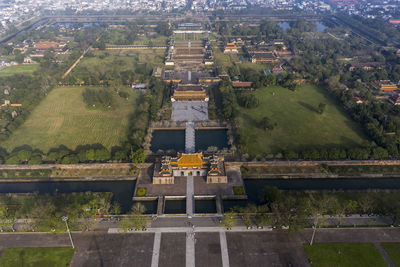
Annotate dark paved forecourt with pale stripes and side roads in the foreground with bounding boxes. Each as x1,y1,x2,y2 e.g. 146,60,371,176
0,228,400,267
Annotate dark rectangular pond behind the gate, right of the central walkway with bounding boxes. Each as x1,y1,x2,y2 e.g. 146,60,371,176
195,129,229,151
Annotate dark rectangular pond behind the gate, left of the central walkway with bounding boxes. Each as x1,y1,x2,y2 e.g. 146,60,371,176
150,130,185,153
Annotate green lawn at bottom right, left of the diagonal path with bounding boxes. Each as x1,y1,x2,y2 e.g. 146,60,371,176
304,243,387,267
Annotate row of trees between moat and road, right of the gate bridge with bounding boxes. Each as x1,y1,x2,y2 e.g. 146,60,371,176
222,186,400,231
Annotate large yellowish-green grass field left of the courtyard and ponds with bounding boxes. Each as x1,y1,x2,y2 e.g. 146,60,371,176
0,86,135,152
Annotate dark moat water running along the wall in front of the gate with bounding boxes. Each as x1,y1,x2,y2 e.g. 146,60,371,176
0,178,400,214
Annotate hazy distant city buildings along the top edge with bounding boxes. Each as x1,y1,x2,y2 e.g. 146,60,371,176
0,0,400,34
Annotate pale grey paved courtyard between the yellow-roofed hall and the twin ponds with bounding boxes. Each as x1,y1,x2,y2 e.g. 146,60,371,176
171,101,208,121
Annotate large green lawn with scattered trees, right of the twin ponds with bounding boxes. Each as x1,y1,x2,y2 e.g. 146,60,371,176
238,85,365,155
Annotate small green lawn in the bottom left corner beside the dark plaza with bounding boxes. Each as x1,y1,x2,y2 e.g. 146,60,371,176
0,247,74,267
